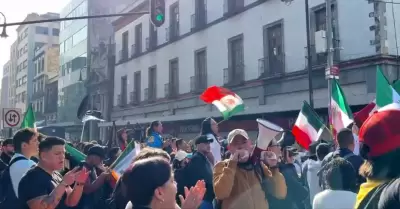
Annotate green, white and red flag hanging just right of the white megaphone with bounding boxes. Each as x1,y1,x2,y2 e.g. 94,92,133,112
292,101,325,150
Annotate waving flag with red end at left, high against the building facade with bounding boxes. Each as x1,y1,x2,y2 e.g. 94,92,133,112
200,86,244,120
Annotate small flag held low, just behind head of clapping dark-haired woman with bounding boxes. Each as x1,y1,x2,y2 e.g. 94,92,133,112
110,141,140,182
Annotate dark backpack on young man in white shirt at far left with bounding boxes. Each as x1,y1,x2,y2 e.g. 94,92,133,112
0,156,27,208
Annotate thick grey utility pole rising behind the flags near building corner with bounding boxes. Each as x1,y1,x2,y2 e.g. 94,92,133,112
325,0,337,132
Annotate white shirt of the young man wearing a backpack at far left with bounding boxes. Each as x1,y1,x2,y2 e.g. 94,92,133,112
10,153,36,197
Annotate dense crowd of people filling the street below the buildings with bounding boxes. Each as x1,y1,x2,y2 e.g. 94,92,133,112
0,106,400,209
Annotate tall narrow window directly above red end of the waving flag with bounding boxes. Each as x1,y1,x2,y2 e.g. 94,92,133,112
192,49,207,91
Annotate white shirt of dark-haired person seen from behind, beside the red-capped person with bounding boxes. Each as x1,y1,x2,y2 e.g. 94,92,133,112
313,189,357,209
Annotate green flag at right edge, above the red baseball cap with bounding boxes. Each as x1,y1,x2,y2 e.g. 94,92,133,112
376,66,400,107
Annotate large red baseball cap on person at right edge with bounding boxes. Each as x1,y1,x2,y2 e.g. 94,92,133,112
359,103,400,157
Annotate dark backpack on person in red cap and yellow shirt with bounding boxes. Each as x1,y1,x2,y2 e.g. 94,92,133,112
356,179,396,209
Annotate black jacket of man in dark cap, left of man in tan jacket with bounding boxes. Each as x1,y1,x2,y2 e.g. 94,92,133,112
183,152,215,202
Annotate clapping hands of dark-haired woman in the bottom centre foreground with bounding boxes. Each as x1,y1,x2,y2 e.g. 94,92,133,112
179,180,206,209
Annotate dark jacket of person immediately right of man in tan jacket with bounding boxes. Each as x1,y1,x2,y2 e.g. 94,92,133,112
267,163,309,209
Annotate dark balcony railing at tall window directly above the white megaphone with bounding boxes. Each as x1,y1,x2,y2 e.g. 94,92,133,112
258,55,285,78
